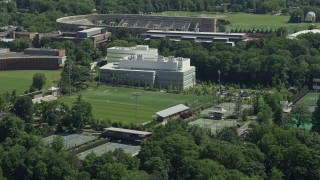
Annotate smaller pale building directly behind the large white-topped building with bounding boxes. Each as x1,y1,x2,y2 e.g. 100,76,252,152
107,45,158,63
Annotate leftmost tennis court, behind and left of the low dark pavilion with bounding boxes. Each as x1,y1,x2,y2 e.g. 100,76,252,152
44,134,98,149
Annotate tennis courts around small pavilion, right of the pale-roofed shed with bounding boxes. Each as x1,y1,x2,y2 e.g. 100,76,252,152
189,118,237,133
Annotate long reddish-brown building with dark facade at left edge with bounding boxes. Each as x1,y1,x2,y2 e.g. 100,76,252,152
0,48,66,70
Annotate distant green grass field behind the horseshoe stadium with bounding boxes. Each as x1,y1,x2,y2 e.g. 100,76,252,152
155,11,319,32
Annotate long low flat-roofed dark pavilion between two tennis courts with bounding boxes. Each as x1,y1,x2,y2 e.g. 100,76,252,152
102,127,151,142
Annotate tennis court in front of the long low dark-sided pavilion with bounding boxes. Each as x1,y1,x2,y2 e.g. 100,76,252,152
78,142,140,159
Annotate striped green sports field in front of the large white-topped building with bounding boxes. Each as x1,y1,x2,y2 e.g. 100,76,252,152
58,86,205,124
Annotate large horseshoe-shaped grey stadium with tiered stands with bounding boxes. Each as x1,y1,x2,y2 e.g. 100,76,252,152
57,14,217,34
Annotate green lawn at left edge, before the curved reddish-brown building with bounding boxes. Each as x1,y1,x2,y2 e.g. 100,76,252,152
0,70,61,94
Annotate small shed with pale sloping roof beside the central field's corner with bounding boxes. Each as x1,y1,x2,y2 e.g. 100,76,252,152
156,104,190,121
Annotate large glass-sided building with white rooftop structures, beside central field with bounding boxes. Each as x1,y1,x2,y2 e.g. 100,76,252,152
100,54,196,90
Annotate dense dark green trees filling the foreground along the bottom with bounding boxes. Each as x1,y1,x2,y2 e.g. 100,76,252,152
0,110,320,180
